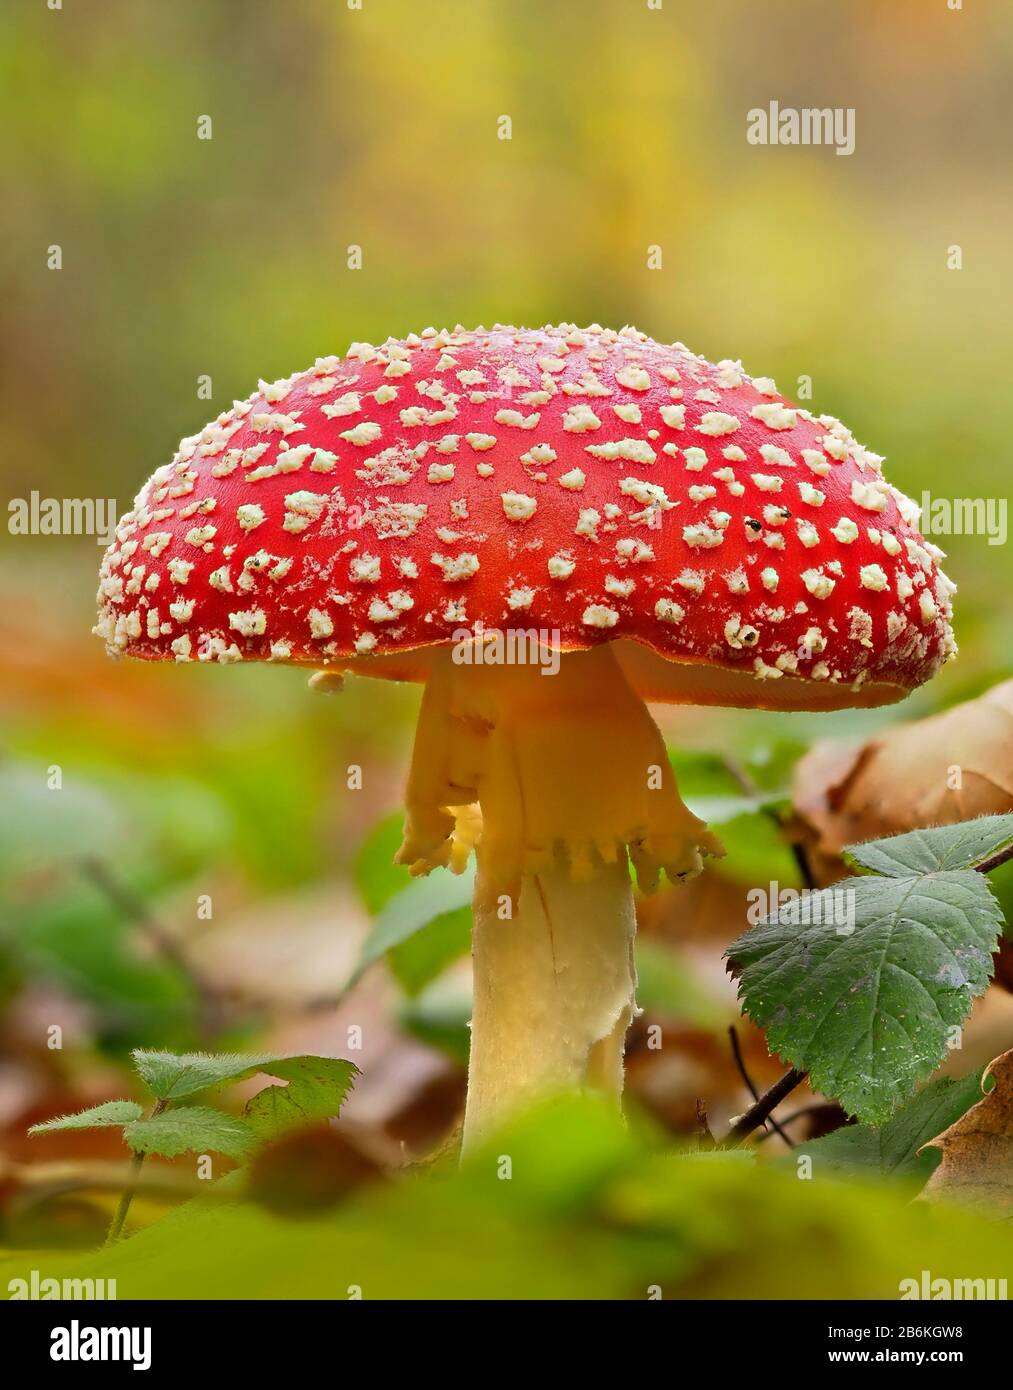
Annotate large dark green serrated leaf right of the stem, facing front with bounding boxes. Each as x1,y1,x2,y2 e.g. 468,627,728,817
727,870,1000,1123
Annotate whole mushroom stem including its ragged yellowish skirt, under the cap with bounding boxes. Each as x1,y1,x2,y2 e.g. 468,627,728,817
397,638,723,1147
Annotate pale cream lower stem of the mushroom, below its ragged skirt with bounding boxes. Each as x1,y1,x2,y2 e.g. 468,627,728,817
464,853,636,1151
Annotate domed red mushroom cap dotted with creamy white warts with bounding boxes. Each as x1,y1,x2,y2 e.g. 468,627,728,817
96,325,953,708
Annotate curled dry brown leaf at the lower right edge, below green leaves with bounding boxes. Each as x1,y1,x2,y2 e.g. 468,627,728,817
921,1049,1013,1220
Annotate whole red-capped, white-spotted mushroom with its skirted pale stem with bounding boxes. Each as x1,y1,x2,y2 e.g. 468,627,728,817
96,325,955,1144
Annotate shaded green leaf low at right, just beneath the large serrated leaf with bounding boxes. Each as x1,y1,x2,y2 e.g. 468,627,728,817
777,1070,981,1184
